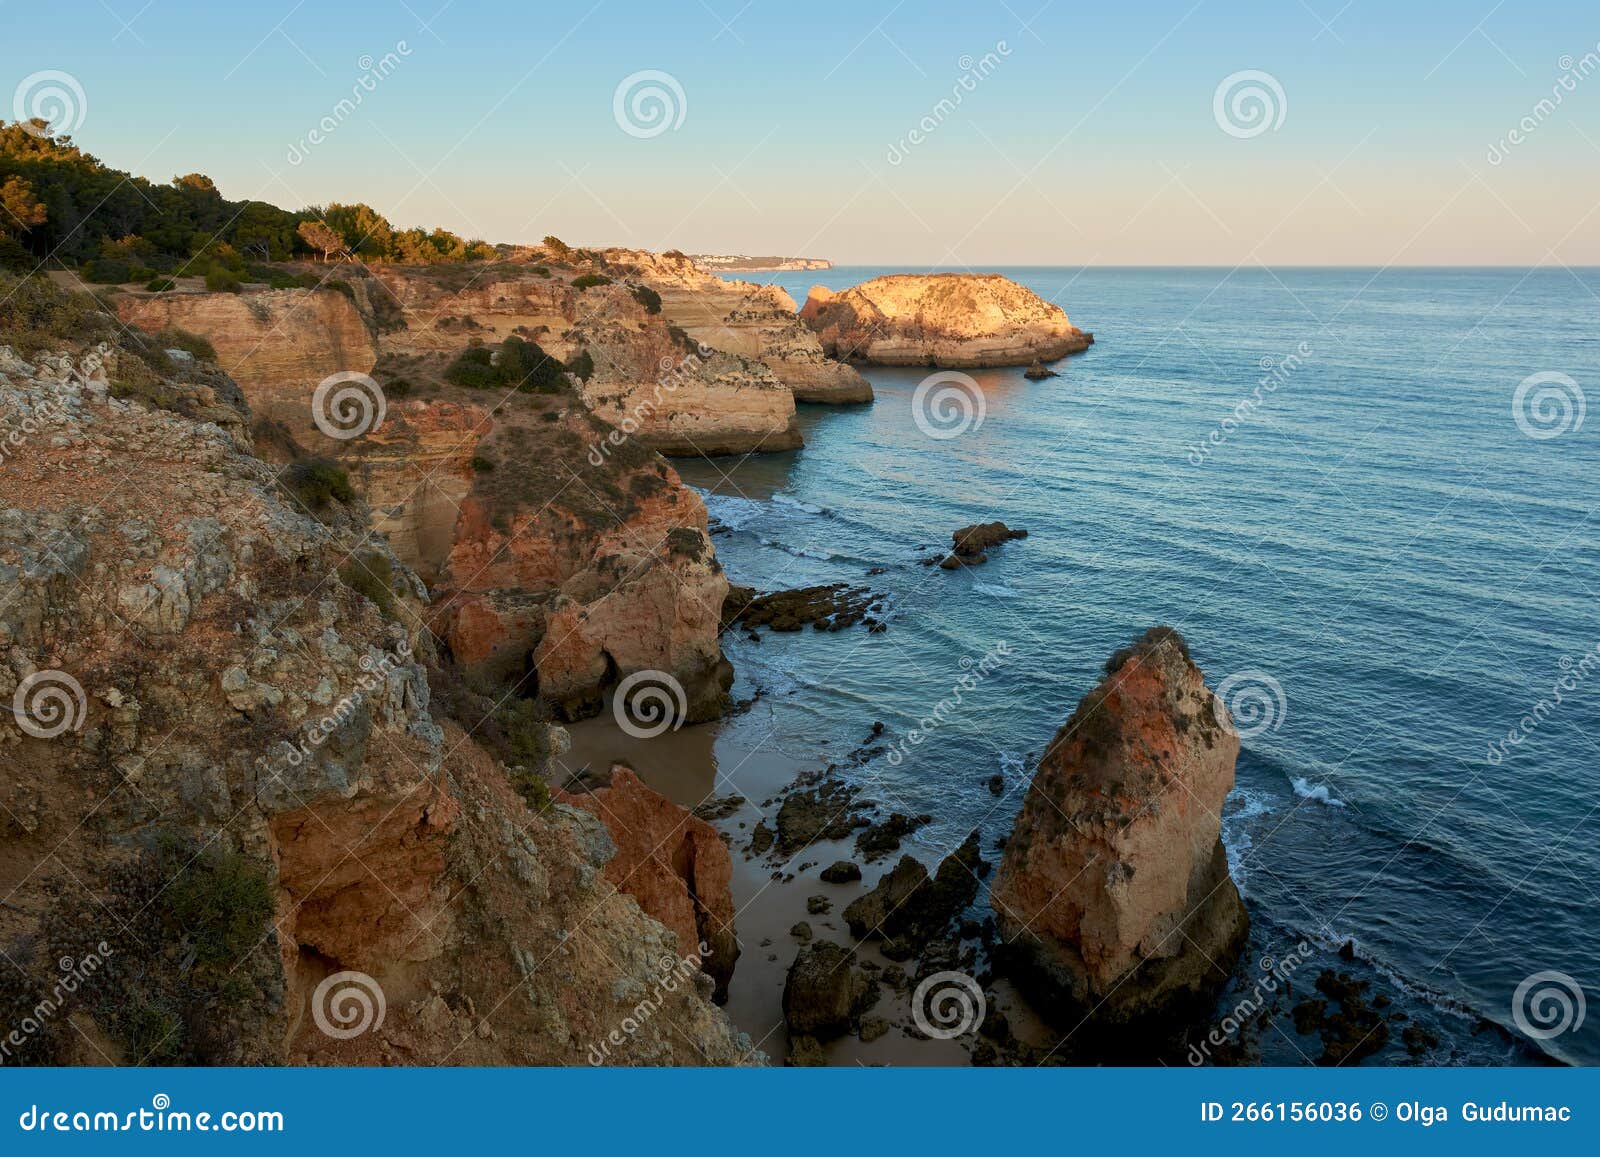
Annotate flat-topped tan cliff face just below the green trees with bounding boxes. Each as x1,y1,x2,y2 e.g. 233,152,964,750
117,288,379,450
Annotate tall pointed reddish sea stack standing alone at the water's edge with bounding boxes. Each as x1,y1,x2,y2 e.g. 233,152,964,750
990,627,1248,1027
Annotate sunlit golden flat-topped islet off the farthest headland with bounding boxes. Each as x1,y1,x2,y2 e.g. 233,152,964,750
800,274,1094,368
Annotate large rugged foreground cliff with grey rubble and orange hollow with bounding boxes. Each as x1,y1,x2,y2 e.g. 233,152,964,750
0,332,758,1064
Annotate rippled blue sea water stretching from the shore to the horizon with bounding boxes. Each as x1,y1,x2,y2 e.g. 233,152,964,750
680,269,1600,1063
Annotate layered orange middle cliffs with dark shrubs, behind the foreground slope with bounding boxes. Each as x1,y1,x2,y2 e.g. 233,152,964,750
120,262,739,720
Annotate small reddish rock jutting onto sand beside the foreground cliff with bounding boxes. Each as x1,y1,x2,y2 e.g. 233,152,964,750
560,765,739,1002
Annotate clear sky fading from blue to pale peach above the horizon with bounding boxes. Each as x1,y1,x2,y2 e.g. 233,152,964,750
0,0,1600,269
